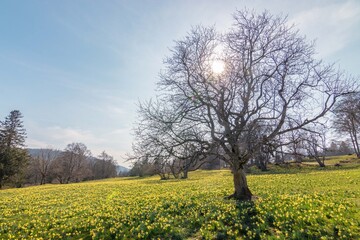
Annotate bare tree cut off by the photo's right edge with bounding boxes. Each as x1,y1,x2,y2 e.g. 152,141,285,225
334,93,360,158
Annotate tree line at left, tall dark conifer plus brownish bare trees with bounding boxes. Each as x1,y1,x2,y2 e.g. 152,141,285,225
0,110,117,188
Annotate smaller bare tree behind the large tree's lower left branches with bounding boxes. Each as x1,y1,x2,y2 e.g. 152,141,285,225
130,101,207,179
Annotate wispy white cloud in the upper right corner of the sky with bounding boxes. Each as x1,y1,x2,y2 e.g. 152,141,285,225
291,1,360,57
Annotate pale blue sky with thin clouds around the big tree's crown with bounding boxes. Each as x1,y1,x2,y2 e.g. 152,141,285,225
0,0,360,166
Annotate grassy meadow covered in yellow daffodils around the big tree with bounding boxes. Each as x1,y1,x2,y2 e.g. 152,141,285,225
0,168,360,239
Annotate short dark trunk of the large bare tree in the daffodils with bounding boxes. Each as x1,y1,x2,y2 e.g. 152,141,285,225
228,168,253,201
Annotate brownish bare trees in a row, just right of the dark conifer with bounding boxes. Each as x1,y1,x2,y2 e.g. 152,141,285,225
26,143,117,184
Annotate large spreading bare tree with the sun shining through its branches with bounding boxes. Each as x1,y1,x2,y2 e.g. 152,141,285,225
133,11,355,200
